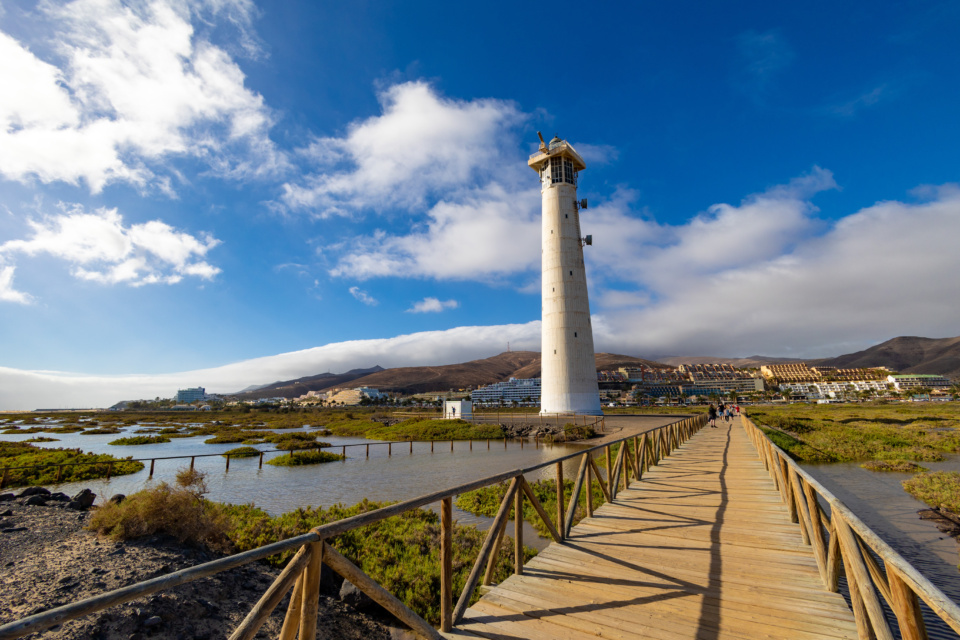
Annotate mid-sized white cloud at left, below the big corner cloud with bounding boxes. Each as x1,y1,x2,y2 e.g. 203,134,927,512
0,205,220,286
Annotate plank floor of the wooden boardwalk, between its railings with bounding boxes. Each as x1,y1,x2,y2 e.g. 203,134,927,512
444,419,857,640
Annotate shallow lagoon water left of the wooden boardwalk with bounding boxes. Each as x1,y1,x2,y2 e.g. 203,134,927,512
2,425,582,549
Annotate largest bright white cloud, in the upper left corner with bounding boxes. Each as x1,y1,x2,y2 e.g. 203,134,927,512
0,0,286,192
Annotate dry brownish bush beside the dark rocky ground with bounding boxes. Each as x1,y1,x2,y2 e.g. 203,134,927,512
87,469,232,551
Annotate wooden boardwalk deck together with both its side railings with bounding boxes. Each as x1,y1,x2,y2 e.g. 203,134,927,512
0,415,960,640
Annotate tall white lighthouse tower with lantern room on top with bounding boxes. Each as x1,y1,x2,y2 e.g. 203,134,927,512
527,132,603,415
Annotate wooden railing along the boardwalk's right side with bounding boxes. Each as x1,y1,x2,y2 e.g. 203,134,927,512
741,415,960,640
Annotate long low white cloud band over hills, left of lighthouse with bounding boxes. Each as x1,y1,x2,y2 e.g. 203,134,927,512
0,322,540,409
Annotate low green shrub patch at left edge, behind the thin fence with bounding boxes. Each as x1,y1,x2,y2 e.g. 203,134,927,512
0,442,143,487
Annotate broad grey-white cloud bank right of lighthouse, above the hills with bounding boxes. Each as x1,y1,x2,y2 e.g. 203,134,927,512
605,185,960,357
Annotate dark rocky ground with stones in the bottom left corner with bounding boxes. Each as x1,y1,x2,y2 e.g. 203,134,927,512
0,487,413,640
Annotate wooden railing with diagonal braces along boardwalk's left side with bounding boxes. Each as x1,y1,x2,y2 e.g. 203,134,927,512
0,415,706,640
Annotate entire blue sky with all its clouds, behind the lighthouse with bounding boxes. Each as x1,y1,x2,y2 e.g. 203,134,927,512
0,0,960,408
